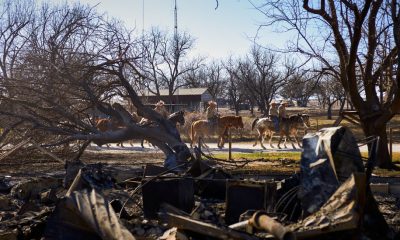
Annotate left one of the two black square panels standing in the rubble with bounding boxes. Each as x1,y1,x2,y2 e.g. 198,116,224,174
142,178,194,219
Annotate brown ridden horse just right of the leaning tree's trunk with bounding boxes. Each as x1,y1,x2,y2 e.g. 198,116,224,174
189,116,243,148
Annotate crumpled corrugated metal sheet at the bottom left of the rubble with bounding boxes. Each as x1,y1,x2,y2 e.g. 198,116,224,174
44,189,135,240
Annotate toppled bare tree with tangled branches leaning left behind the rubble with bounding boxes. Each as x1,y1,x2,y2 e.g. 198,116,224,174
0,0,191,168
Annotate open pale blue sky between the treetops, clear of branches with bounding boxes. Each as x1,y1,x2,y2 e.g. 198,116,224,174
51,0,285,59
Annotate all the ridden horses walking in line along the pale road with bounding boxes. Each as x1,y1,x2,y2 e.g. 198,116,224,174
95,111,310,149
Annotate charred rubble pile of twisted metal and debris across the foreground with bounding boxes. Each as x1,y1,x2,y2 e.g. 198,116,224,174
0,127,399,240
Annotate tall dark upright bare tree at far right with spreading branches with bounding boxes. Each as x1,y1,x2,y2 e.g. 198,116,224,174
258,0,400,168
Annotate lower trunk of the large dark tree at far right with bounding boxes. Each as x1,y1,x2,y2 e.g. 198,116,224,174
362,119,394,169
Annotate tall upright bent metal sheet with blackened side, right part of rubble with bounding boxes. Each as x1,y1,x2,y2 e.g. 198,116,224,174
298,127,364,216
